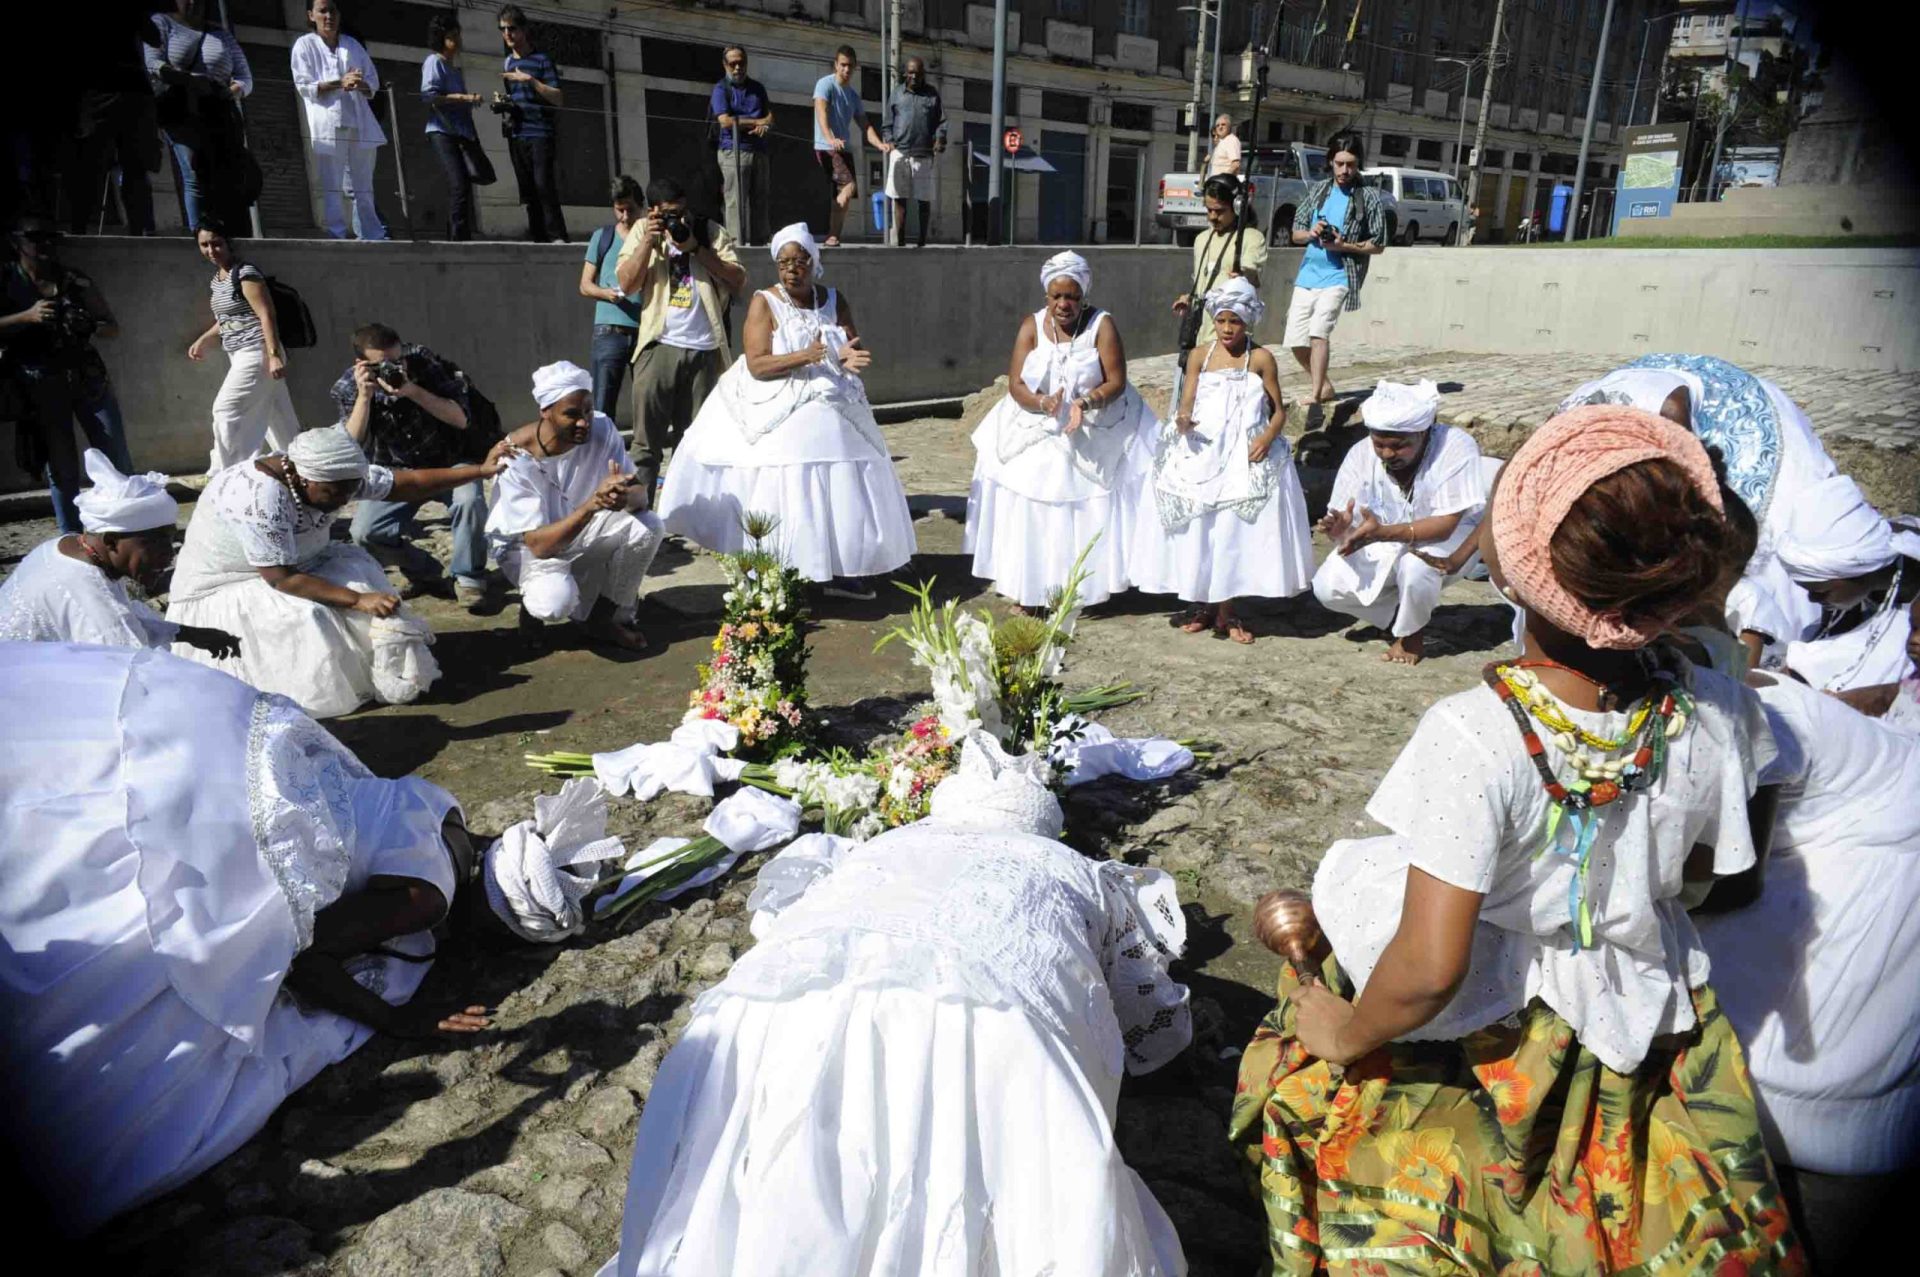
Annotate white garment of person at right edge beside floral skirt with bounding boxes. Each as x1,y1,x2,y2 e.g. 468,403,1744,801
1695,678,1920,1175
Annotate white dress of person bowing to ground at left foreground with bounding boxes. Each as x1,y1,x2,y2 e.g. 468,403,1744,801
0,643,455,1229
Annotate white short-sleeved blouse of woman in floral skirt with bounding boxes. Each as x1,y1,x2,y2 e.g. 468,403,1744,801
1313,670,1774,1073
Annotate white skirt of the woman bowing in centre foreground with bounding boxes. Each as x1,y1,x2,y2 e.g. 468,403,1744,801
601,987,1187,1277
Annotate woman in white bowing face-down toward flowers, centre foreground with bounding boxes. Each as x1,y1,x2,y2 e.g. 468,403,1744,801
603,734,1192,1277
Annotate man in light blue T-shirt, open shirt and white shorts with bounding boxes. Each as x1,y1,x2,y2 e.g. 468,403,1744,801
1286,133,1386,403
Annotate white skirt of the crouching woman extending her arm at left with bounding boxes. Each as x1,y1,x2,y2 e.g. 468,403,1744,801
167,543,440,718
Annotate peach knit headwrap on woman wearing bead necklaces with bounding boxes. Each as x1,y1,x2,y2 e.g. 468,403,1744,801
1492,403,1720,649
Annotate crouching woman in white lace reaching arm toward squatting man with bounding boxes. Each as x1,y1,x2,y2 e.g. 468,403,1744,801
167,426,505,718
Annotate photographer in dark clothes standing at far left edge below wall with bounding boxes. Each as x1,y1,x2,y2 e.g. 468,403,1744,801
0,217,132,532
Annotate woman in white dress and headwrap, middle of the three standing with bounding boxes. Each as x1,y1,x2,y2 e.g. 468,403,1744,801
966,253,1160,609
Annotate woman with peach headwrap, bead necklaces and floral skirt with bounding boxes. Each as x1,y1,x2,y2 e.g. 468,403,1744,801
1229,405,1807,1275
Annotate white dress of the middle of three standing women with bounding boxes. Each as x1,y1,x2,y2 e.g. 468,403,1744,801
966,311,1160,607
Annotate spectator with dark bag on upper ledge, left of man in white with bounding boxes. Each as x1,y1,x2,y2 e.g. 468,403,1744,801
146,0,253,227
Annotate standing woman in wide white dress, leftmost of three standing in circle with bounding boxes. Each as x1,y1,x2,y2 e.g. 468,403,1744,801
660,223,916,599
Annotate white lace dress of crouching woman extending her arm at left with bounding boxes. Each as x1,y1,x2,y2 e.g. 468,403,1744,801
167,461,440,718
